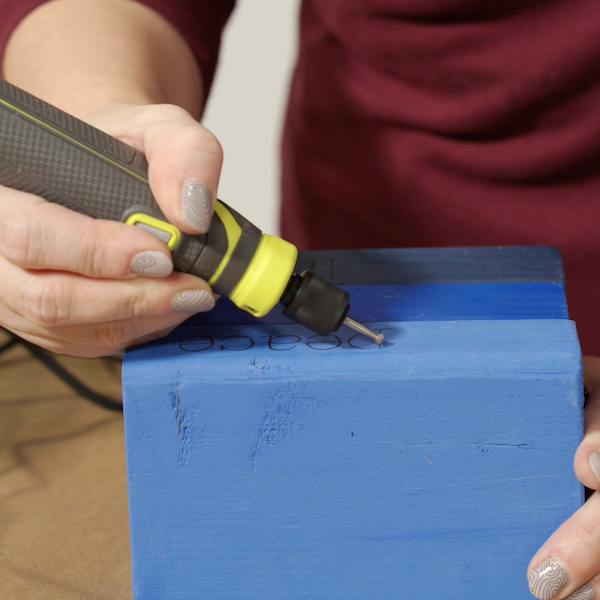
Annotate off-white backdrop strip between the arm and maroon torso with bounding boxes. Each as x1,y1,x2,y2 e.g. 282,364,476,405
202,0,299,234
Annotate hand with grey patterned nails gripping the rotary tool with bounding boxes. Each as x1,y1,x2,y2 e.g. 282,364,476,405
0,105,222,356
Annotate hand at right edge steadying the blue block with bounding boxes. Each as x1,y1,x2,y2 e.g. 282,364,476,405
527,357,600,600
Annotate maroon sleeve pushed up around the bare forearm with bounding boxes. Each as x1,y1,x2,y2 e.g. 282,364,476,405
0,0,235,96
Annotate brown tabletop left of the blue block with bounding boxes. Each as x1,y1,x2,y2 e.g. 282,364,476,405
0,334,131,600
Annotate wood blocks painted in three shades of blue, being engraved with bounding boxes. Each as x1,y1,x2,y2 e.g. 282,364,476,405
123,249,583,600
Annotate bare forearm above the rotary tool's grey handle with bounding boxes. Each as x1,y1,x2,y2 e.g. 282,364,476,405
3,0,203,117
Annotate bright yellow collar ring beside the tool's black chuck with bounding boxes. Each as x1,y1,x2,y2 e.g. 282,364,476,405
229,234,298,317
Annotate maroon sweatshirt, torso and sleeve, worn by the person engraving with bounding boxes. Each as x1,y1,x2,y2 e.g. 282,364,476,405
0,0,600,356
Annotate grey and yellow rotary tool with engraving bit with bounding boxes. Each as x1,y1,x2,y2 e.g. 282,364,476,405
0,79,383,344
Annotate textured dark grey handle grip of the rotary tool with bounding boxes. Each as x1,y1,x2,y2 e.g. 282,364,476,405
0,80,206,272
